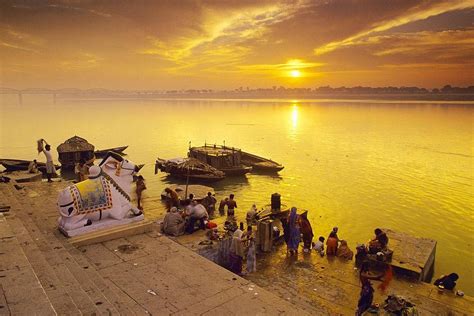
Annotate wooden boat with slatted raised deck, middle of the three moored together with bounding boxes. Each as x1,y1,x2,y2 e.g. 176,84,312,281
188,144,252,176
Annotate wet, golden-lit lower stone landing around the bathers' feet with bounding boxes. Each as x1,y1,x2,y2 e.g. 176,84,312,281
176,231,474,315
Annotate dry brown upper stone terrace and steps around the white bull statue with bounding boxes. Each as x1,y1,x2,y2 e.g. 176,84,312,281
0,182,307,315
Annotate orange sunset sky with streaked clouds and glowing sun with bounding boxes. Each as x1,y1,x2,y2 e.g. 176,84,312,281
0,0,474,89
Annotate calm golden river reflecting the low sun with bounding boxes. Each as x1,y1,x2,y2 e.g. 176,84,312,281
0,96,474,295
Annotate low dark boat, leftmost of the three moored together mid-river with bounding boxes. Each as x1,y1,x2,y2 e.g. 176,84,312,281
155,158,225,182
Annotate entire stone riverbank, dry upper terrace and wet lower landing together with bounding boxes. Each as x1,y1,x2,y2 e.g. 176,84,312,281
0,181,474,315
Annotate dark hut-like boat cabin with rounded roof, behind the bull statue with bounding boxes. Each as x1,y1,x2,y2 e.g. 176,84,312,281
57,136,94,169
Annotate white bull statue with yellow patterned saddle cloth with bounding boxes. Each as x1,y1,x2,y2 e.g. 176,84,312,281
58,152,143,236
